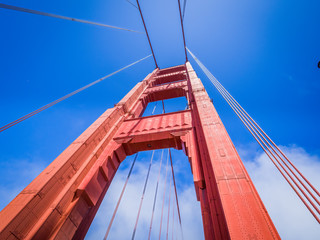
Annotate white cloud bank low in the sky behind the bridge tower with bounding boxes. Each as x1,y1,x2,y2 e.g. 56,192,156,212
0,144,320,240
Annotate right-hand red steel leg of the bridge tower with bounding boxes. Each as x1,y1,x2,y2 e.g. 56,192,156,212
186,62,280,240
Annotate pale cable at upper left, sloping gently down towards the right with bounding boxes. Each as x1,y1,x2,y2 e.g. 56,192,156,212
0,3,143,34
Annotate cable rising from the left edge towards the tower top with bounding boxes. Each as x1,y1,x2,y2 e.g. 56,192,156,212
0,54,151,132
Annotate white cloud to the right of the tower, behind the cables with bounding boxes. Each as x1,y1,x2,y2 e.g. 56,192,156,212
239,146,320,240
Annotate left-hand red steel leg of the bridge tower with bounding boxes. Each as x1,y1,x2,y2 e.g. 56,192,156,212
0,69,159,239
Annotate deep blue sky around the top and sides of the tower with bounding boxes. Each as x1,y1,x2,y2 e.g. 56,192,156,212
0,0,320,239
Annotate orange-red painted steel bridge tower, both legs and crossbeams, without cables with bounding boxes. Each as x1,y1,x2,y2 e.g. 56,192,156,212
0,62,280,239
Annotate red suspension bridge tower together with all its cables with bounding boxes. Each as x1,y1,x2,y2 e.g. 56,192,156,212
0,0,320,239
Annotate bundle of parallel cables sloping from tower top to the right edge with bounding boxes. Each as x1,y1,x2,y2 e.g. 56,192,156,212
187,49,320,223
